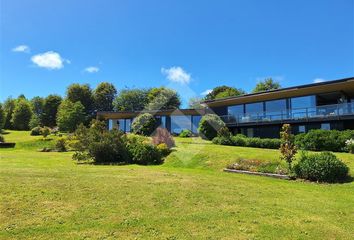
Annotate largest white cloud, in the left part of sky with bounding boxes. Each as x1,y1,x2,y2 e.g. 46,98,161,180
31,51,70,70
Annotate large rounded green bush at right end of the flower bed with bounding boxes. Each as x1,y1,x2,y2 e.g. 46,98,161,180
294,152,349,182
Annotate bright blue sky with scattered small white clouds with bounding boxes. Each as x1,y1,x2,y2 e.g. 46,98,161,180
0,0,354,106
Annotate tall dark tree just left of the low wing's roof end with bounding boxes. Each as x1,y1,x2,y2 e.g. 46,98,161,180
93,82,117,111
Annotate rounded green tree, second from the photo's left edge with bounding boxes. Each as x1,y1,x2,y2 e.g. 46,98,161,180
11,99,33,130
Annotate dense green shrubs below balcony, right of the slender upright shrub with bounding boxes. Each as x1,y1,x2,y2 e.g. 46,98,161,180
295,129,354,152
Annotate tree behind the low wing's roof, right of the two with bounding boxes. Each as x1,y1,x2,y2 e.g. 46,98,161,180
147,87,181,110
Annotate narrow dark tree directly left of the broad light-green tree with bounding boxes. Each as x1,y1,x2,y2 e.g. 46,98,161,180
41,95,62,127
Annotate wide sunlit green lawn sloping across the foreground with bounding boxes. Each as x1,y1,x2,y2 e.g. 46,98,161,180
0,132,354,239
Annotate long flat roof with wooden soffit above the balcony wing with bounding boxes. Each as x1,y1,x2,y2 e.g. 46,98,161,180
202,77,354,107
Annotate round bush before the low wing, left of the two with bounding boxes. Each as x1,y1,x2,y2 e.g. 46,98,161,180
132,113,156,136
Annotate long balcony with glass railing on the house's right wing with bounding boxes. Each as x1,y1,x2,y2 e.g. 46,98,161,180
220,103,354,125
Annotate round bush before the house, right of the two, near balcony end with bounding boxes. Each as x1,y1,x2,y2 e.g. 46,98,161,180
198,114,226,140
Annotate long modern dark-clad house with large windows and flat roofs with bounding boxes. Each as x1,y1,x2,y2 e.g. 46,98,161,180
98,77,354,138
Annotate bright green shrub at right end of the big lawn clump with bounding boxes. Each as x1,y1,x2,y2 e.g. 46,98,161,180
127,136,162,165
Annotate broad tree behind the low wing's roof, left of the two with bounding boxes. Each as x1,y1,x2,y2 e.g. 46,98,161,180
113,88,149,111
